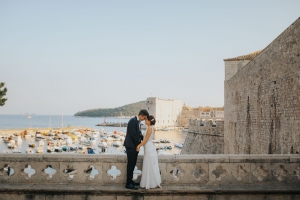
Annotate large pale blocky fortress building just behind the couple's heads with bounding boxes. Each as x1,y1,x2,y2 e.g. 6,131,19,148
146,97,183,128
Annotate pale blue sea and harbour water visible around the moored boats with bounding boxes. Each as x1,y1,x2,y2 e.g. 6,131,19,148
0,115,187,154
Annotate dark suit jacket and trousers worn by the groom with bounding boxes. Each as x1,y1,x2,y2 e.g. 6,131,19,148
124,117,141,184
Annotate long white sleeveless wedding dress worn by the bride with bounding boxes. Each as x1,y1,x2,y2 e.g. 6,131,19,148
140,126,161,189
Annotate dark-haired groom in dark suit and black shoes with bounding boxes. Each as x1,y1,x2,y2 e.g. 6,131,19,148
124,109,149,190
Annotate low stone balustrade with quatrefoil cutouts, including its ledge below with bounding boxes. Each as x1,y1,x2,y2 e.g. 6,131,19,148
0,154,300,200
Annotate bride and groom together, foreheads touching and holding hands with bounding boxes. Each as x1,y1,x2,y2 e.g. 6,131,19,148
124,110,161,190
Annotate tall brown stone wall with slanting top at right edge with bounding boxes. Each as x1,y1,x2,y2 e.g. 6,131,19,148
224,18,300,154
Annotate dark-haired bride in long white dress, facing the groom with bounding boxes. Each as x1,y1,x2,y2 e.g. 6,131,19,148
136,115,161,189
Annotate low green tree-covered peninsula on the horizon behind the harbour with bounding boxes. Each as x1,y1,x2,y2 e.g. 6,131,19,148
74,101,146,117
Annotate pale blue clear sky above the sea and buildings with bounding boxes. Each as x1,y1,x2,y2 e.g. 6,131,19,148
0,0,300,115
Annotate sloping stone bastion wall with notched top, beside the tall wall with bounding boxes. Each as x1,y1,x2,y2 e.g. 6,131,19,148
181,119,224,154
